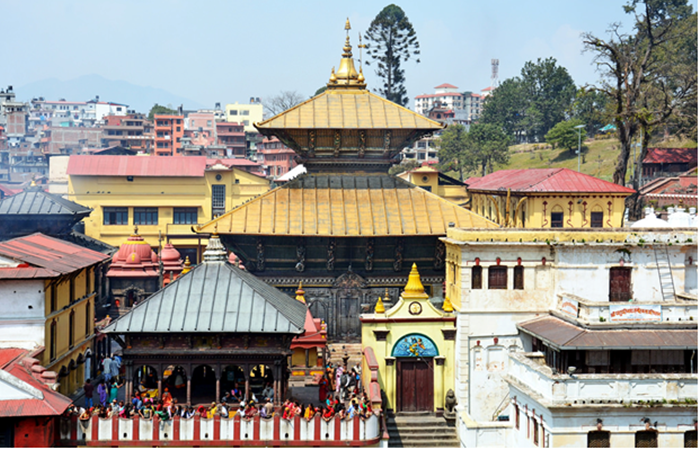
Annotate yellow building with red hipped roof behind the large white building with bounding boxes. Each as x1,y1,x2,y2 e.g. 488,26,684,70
465,168,634,228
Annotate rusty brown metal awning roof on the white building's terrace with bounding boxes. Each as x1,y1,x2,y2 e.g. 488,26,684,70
517,316,698,350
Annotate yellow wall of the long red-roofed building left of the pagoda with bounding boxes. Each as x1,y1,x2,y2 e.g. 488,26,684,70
68,169,270,247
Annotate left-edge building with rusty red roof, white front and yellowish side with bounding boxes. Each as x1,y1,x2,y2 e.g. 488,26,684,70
0,233,109,395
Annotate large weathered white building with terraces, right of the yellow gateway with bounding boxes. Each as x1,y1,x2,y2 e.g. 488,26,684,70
444,228,698,447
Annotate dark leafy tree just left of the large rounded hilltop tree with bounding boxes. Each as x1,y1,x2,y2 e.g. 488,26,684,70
479,77,526,135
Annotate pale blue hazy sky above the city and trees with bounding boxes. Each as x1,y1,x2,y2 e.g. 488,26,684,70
0,0,652,107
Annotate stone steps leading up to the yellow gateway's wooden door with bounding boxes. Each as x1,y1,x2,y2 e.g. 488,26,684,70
386,412,459,448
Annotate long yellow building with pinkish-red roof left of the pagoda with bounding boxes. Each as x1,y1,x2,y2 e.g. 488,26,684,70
67,155,269,263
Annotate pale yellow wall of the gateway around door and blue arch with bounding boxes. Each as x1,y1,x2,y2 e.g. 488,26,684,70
361,265,456,411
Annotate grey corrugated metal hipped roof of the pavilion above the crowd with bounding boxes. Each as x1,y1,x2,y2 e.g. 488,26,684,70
104,261,306,334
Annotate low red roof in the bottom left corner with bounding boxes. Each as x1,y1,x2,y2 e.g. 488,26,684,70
0,348,72,417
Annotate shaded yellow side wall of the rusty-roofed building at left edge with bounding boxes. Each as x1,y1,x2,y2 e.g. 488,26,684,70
40,268,95,395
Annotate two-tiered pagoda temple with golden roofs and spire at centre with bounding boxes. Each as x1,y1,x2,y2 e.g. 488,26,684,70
197,22,498,342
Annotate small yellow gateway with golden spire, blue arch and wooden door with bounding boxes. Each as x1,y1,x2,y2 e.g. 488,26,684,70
360,264,456,414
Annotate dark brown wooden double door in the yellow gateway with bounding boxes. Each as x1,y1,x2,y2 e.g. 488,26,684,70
396,358,434,412
